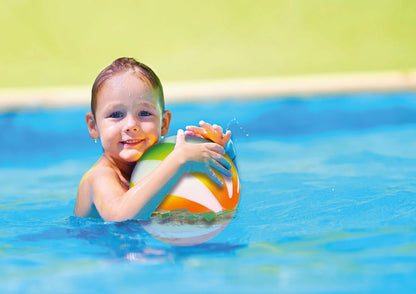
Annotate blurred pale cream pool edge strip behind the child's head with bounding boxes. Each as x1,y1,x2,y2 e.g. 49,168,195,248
0,70,416,111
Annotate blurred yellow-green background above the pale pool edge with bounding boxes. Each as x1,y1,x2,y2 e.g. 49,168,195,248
0,0,416,88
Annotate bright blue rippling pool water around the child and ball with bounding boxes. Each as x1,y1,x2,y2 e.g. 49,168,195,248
0,92,416,293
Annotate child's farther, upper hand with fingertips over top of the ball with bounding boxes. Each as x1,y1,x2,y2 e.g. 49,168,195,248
185,120,231,148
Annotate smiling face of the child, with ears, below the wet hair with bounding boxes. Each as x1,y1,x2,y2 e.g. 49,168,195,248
87,72,170,163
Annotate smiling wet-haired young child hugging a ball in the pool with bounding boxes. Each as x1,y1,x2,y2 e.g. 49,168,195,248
74,58,231,221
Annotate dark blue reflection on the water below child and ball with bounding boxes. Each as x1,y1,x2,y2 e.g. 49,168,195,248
17,216,245,263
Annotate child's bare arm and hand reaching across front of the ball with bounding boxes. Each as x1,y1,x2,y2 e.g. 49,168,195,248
83,131,231,221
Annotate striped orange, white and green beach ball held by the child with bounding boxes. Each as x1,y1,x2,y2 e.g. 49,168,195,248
130,136,240,246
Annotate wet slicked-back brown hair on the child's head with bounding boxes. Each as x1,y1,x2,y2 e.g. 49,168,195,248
91,57,165,117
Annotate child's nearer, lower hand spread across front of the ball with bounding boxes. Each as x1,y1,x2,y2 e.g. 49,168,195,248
174,130,232,186
